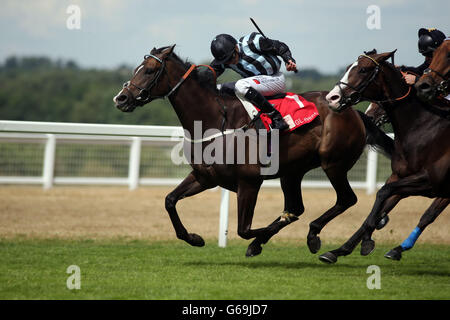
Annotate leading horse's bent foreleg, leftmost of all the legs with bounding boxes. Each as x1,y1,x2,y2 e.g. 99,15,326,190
166,172,215,247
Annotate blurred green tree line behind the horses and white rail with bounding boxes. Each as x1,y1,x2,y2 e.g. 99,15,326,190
0,56,366,125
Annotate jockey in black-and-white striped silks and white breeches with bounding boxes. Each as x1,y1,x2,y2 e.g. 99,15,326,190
211,32,297,131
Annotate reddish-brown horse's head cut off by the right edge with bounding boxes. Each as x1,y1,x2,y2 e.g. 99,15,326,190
415,40,450,101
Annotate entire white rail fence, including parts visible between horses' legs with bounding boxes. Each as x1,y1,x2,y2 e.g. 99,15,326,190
0,121,390,247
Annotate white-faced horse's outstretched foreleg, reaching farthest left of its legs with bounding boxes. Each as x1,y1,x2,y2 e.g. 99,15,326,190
319,172,432,263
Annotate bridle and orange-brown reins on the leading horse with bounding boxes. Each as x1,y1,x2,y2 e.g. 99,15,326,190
123,54,217,104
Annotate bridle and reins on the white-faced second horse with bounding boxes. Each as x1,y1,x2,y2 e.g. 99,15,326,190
336,54,411,111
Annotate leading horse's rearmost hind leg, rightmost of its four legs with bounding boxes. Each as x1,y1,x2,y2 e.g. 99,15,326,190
307,166,358,253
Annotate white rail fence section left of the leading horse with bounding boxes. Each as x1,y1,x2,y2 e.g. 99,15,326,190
0,121,183,190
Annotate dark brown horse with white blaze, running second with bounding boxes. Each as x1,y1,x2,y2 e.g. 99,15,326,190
320,51,450,263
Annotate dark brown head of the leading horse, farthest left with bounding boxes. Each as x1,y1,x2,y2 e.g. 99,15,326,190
113,45,175,112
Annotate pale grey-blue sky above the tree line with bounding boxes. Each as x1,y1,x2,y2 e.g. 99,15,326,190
0,0,450,73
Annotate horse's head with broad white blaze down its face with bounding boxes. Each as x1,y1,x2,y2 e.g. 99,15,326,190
326,50,396,112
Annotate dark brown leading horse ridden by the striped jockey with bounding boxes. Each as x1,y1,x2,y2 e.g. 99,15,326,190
114,46,390,256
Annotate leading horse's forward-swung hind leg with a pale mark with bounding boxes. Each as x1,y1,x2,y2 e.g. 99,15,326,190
246,175,305,257
